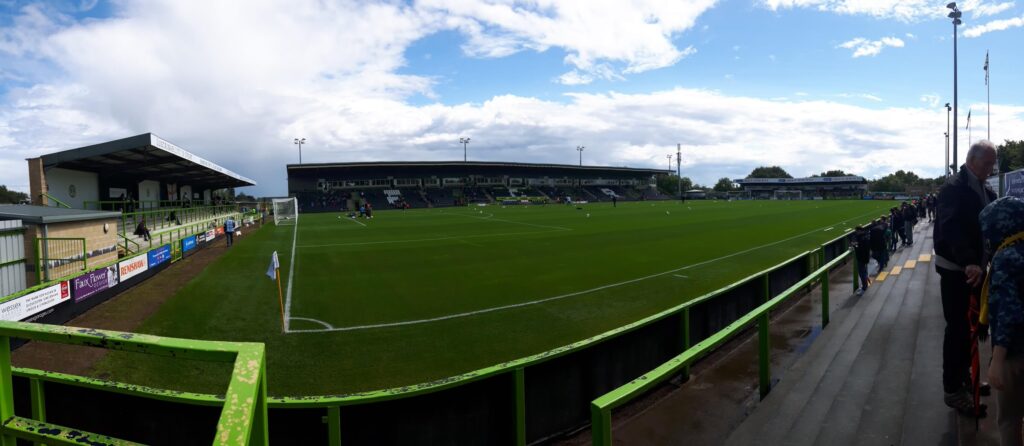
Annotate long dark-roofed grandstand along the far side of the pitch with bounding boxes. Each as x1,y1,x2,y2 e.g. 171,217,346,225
288,162,667,212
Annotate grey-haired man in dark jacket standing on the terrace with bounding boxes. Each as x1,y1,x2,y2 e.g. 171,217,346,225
933,140,995,414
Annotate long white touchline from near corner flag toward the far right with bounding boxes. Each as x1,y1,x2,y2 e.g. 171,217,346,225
286,207,880,332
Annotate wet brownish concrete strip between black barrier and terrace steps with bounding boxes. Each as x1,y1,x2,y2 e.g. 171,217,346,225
554,265,857,445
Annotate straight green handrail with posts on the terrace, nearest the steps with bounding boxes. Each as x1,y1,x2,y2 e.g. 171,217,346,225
591,246,857,446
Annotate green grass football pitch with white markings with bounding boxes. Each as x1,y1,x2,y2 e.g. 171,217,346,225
94,200,891,396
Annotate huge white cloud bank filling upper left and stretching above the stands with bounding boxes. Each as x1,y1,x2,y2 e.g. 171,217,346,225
0,1,1024,194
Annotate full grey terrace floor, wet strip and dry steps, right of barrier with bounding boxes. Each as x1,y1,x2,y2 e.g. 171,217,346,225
613,222,998,446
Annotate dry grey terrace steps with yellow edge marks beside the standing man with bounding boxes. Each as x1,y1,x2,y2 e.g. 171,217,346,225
726,223,998,446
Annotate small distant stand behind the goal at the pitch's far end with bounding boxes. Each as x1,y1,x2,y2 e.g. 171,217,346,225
733,175,867,199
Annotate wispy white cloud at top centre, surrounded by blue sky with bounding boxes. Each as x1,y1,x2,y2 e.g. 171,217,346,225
417,0,716,80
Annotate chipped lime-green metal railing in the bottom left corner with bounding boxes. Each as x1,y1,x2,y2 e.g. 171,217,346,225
0,321,268,446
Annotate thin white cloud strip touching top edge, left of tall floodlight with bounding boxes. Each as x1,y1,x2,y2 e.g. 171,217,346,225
761,0,946,21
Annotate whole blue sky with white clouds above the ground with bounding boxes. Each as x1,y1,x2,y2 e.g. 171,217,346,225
0,0,1024,195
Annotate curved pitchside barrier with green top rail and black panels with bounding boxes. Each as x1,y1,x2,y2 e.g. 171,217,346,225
0,228,851,445
